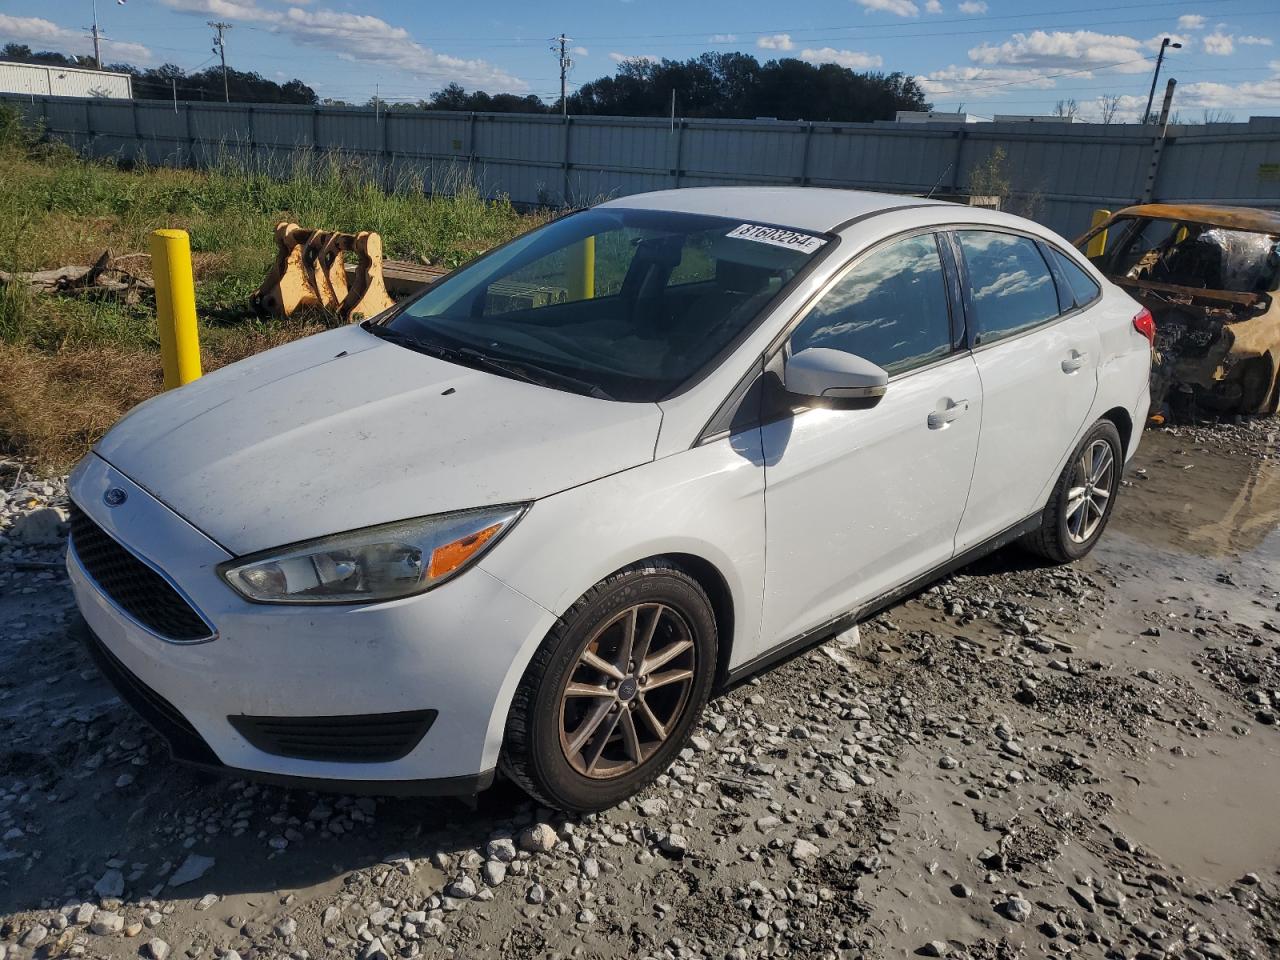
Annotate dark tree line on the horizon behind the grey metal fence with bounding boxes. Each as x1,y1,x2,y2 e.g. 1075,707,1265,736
0,44,929,122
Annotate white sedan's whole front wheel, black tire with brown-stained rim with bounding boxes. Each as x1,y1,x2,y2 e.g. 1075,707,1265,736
499,561,719,813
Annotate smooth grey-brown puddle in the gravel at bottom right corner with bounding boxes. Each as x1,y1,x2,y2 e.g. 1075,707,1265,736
1114,731,1280,884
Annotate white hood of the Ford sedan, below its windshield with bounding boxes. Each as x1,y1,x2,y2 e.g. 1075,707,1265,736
95,326,662,554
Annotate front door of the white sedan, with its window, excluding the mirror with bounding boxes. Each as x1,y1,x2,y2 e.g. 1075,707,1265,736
760,233,982,648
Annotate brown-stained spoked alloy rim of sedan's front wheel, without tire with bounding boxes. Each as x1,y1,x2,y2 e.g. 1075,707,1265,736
559,603,698,780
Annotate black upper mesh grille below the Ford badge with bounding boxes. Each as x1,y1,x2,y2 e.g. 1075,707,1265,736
70,503,212,643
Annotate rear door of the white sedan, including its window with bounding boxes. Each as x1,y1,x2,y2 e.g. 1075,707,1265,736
951,228,1101,552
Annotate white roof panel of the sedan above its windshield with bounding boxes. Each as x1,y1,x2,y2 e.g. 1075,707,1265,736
600,187,943,233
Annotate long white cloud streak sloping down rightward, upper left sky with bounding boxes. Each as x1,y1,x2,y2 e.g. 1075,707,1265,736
161,0,529,92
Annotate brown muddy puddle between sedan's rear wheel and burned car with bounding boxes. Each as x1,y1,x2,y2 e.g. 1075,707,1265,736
1110,430,1280,566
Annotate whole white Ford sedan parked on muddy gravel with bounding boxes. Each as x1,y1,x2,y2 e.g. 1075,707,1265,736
68,187,1152,810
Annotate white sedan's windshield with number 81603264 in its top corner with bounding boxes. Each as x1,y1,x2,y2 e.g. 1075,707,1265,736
370,209,829,401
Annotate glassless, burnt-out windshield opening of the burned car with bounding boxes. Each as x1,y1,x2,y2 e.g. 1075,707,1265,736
1093,218,1280,293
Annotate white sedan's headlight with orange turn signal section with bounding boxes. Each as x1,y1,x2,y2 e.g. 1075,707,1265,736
218,504,526,603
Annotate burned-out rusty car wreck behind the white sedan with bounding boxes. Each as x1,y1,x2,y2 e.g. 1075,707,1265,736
1076,204,1280,416
